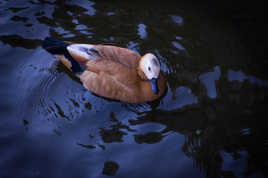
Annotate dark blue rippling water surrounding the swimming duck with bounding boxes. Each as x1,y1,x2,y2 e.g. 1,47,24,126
0,0,268,178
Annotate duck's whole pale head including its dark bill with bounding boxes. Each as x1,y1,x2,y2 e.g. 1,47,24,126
139,53,160,94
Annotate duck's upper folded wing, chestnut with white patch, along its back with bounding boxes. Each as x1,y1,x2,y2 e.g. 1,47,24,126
67,44,141,68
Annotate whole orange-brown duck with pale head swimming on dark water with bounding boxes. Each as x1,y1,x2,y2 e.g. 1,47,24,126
41,37,166,103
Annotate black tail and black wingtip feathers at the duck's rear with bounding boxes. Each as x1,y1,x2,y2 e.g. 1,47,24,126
42,37,85,74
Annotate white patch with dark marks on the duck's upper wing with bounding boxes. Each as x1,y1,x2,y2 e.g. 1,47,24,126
67,44,101,60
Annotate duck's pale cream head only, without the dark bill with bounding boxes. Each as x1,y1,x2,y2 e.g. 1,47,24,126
140,53,160,80
